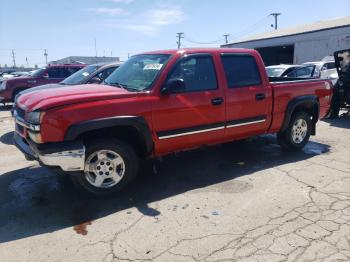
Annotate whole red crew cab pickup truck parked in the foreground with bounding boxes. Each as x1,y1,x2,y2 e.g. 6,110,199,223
14,48,332,195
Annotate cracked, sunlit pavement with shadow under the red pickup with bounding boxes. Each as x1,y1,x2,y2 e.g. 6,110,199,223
0,105,350,262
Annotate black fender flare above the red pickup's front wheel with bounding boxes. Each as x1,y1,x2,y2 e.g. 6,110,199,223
64,116,153,154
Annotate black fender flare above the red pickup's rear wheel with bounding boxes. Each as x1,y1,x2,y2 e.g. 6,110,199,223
280,95,320,135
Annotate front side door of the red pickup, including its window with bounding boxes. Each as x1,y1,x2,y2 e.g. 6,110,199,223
153,54,225,154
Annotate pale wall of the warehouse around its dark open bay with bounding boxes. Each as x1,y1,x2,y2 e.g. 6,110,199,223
227,26,350,64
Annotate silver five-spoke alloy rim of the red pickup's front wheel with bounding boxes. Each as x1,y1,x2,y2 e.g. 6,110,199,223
84,150,125,188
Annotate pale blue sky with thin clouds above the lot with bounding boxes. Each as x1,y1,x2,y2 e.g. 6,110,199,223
0,0,350,65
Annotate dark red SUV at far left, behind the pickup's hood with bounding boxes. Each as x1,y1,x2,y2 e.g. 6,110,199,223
0,64,86,103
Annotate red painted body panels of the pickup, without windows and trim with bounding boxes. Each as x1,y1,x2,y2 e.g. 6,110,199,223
18,48,332,156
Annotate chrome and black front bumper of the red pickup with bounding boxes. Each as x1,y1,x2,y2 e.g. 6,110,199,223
14,132,85,171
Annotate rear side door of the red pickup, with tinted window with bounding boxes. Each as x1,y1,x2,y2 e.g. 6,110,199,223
221,53,272,139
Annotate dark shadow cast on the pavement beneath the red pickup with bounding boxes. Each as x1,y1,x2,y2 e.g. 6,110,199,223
0,135,329,243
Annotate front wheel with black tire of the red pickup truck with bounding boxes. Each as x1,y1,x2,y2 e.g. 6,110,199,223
72,138,140,196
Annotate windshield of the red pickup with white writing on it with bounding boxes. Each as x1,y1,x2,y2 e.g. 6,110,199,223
105,54,170,91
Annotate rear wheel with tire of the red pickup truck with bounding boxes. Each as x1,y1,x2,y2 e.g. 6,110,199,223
277,111,312,151
